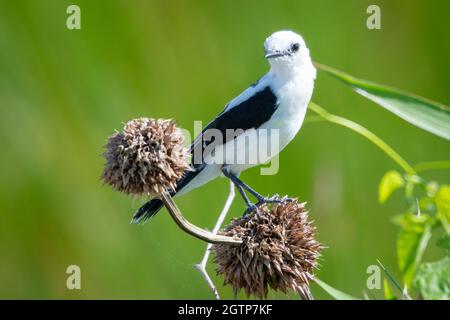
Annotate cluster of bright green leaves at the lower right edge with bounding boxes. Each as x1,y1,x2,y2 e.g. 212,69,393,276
380,171,450,299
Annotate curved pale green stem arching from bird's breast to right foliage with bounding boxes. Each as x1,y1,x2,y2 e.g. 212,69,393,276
309,102,416,174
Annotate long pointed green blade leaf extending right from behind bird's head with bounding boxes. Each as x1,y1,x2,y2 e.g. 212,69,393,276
315,63,450,140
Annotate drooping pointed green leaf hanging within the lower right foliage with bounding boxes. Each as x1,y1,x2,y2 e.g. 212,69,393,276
397,225,431,288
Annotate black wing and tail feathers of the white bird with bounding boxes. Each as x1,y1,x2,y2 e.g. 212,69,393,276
133,86,278,222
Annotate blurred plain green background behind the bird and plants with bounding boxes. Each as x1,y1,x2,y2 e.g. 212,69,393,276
0,0,450,299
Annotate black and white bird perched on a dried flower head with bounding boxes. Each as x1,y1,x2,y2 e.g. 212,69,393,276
133,31,316,223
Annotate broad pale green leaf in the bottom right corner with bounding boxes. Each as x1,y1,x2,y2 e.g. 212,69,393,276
414,256,450,300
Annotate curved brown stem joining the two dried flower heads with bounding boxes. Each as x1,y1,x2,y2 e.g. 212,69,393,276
160,191,242,245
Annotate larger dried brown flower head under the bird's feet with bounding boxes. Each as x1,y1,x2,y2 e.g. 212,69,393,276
212,200,322,299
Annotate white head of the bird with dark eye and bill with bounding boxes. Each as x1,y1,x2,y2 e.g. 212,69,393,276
264,31,316,79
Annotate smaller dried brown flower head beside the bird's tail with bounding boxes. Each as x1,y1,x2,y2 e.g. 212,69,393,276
102,118,189,195
